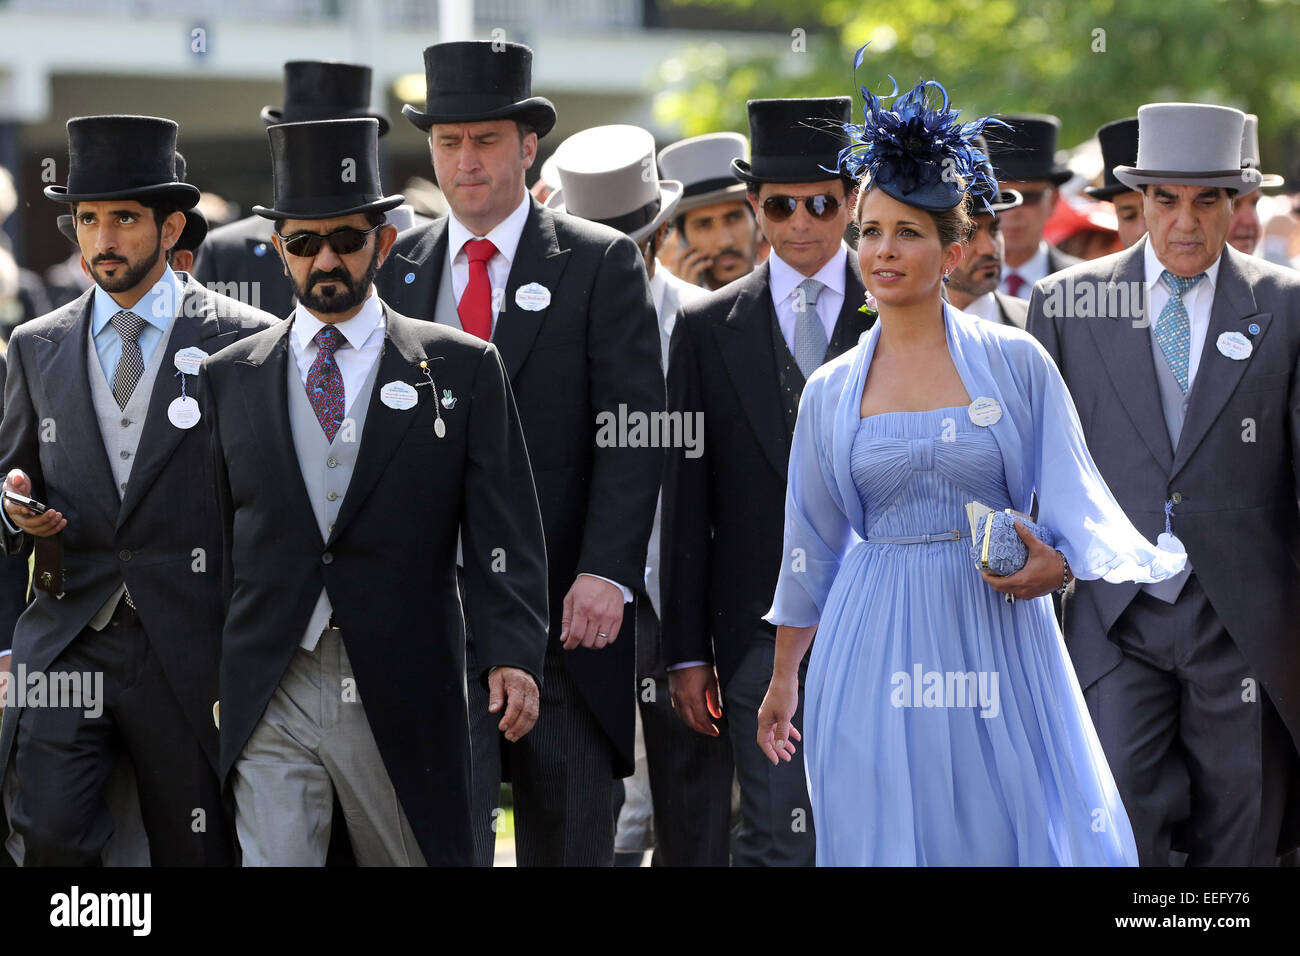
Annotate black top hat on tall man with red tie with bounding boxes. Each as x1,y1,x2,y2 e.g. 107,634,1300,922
402,40,555,137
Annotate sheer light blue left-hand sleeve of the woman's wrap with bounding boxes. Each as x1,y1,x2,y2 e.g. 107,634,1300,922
763,372,854,627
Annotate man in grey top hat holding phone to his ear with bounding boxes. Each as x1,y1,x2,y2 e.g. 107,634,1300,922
659,133,759,289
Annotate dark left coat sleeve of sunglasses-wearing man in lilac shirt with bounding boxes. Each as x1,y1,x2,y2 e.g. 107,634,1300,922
659,310,714,666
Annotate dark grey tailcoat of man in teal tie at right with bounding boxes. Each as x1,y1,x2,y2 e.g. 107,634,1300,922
1028,238,1300,740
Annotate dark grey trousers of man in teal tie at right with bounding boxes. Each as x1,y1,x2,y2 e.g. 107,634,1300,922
1083,574,1296,866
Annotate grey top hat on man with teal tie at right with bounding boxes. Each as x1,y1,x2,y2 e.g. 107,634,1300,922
1114,103,1262,195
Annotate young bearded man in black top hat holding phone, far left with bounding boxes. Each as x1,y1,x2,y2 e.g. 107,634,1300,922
0,116,273,866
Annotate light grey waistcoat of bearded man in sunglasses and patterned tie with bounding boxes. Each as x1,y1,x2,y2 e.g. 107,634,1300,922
285,350,381,650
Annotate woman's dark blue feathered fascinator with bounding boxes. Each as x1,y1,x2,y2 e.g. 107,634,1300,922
840,46,1010,213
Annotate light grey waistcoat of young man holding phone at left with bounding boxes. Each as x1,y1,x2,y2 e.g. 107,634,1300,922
86,317,180,631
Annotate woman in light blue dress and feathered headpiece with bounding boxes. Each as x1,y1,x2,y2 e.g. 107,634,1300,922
758,74,1187,866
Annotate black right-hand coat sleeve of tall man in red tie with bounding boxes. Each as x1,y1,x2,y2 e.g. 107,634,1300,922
577,235,664,591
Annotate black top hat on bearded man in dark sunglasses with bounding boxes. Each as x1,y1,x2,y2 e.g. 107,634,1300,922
252,117,404,219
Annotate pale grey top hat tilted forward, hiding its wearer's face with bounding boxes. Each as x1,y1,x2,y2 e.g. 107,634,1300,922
546,126,683,242
